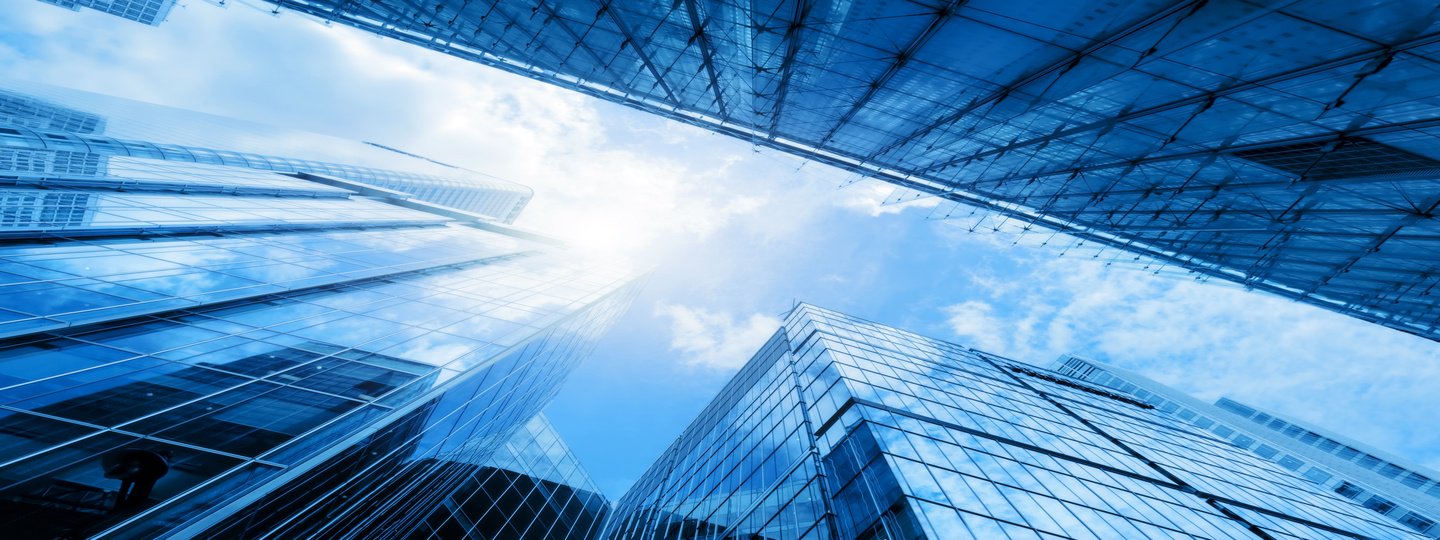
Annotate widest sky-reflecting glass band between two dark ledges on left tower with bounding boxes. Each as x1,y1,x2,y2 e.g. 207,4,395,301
0,222,530,336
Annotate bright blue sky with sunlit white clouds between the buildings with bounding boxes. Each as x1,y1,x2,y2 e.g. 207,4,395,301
0,0,1440,497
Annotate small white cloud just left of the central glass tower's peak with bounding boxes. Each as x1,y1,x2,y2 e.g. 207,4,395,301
655,304,780,370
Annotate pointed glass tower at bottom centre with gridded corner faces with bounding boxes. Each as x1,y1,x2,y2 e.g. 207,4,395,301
608,305,1424,540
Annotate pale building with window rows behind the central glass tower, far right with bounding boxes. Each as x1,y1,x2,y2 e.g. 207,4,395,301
1054,356,1440,539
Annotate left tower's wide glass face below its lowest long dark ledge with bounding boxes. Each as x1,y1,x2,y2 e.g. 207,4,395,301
0,243,636,538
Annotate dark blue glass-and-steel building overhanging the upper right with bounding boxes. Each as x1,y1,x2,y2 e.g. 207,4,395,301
250,0,1440,340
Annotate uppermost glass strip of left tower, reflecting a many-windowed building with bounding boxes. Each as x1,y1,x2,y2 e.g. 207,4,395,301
0,81,534,223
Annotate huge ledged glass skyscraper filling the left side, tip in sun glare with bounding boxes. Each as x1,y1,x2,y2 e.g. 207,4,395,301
0,84,634,539
